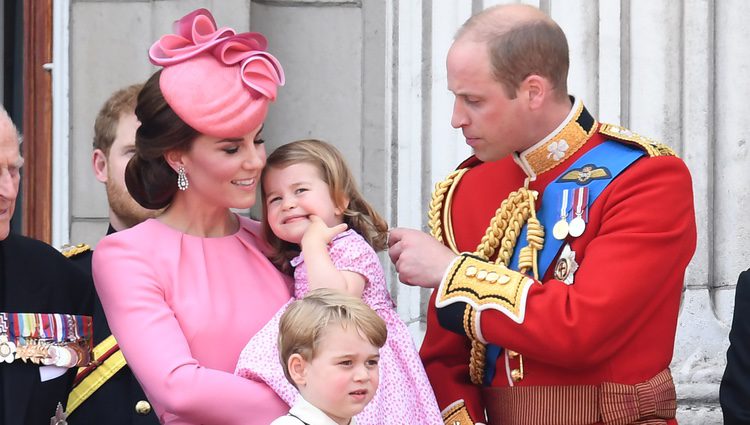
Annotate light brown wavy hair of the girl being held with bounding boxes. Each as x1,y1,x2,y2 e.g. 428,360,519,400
260,139,388,274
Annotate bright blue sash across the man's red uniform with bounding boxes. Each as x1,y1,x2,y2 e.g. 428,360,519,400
483,140,645,386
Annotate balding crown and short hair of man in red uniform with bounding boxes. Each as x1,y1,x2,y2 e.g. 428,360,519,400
456,6,570,98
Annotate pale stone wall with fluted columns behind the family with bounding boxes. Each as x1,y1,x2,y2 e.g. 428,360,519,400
61,0,736,424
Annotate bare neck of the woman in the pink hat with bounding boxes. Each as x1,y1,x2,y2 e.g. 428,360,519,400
158,195,239,238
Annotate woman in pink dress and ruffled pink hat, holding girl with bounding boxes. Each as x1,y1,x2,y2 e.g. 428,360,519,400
93,9,290,425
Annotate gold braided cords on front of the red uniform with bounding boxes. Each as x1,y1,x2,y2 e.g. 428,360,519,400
427,168,544,385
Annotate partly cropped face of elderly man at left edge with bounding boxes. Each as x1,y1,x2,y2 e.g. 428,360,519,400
0,117,23,240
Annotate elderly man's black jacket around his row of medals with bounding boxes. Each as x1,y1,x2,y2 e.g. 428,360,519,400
0,234,94,425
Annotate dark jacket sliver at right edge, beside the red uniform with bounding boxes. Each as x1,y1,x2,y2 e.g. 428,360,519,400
719,270,750,425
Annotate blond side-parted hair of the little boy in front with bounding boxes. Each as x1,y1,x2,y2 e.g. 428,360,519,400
279,288,388,386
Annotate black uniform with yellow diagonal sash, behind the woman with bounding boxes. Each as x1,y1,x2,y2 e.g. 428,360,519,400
68,225,159,425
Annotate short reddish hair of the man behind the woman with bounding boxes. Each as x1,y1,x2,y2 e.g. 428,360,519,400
93,84,143,155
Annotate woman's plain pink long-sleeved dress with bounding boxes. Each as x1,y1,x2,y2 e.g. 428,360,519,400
93,218,290,424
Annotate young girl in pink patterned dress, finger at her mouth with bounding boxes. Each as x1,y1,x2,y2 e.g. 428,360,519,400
235,140,443,425
